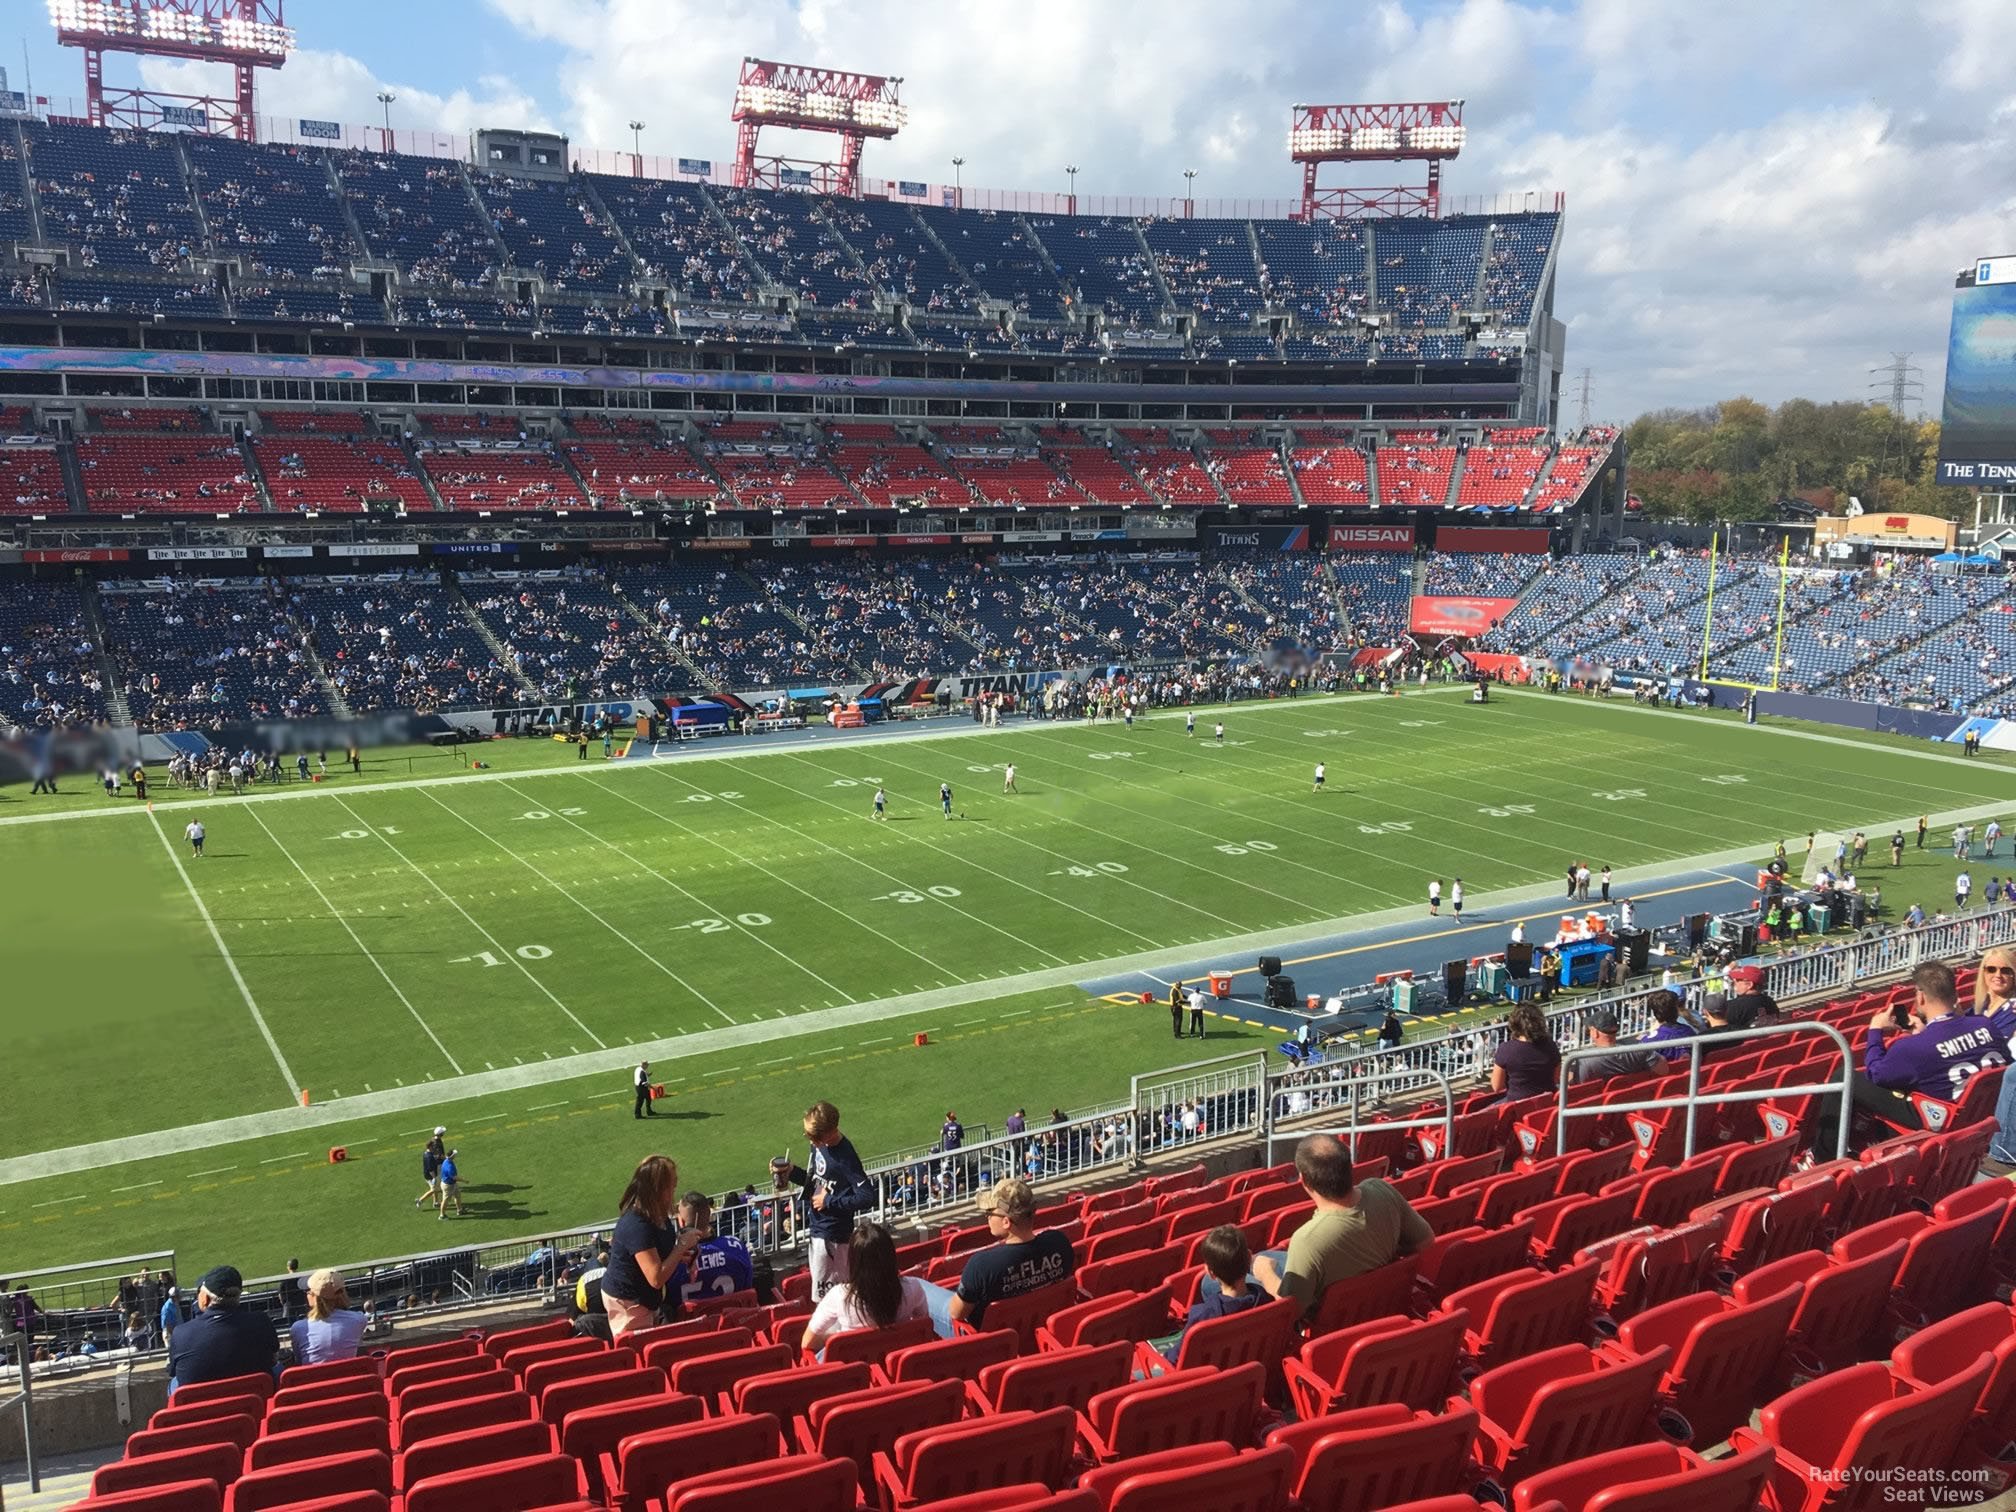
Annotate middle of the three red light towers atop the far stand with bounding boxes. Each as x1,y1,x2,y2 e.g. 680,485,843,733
730,58,909,198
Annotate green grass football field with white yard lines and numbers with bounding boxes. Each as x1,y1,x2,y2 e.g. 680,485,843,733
0,691,2012,1274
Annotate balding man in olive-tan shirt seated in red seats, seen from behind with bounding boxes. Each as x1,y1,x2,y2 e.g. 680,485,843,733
1233,1135,1435,1318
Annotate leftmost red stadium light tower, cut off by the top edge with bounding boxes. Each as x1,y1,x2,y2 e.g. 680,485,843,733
48,0,294,141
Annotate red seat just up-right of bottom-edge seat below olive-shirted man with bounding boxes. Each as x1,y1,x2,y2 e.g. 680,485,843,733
1470,1345,1673,1486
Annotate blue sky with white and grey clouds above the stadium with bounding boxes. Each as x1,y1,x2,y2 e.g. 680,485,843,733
8,0,2016,419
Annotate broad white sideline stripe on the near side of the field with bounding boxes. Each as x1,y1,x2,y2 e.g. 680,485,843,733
0,806,2008,1185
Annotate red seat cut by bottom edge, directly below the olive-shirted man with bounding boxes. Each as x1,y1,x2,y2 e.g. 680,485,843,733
1266,1403,1478,1512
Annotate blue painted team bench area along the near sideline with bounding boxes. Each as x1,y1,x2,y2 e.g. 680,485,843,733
1083,871,1756,1022
